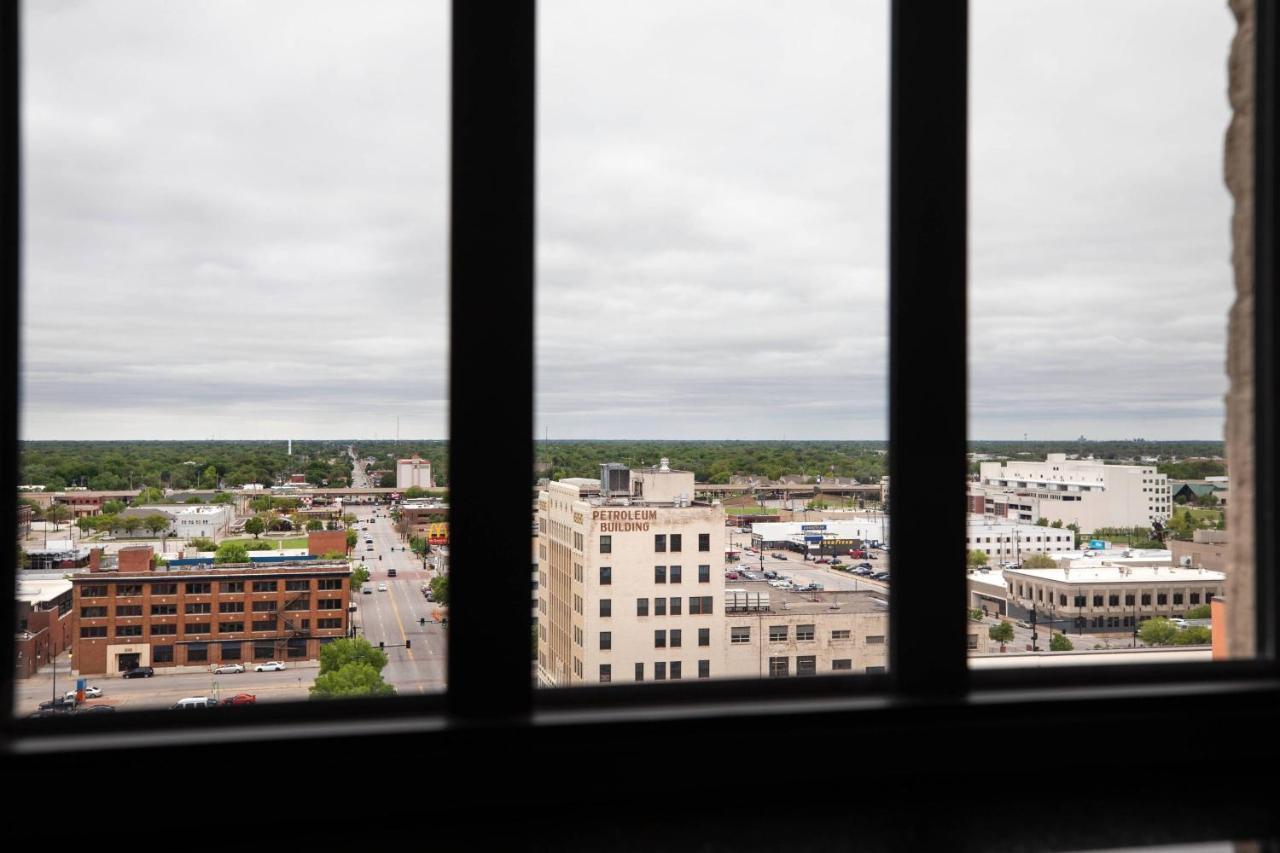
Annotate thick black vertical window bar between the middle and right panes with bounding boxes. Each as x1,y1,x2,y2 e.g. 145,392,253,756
890,0,969,695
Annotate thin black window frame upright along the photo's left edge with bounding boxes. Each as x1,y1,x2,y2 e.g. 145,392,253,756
0,3,22,727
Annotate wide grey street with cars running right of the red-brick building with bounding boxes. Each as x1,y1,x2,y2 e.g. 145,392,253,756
349,506,448,694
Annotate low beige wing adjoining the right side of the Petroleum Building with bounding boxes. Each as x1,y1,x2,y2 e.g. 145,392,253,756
722,581,888,678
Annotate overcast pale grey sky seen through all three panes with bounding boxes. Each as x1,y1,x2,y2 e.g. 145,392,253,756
22,0,1234,439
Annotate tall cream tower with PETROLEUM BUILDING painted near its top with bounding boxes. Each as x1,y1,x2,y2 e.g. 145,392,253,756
538,460,724,686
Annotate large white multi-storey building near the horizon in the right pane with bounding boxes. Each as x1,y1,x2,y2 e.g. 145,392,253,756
969,453,1172,533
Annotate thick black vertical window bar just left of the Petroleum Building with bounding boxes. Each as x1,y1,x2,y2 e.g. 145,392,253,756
448,0,536,719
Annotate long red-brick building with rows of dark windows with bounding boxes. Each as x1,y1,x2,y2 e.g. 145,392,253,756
72,547,351,675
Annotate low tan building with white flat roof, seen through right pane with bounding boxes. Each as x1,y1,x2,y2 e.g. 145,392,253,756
1004,561,1226,633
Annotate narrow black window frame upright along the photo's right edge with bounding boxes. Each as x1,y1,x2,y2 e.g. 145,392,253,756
1254,1,1280,661
